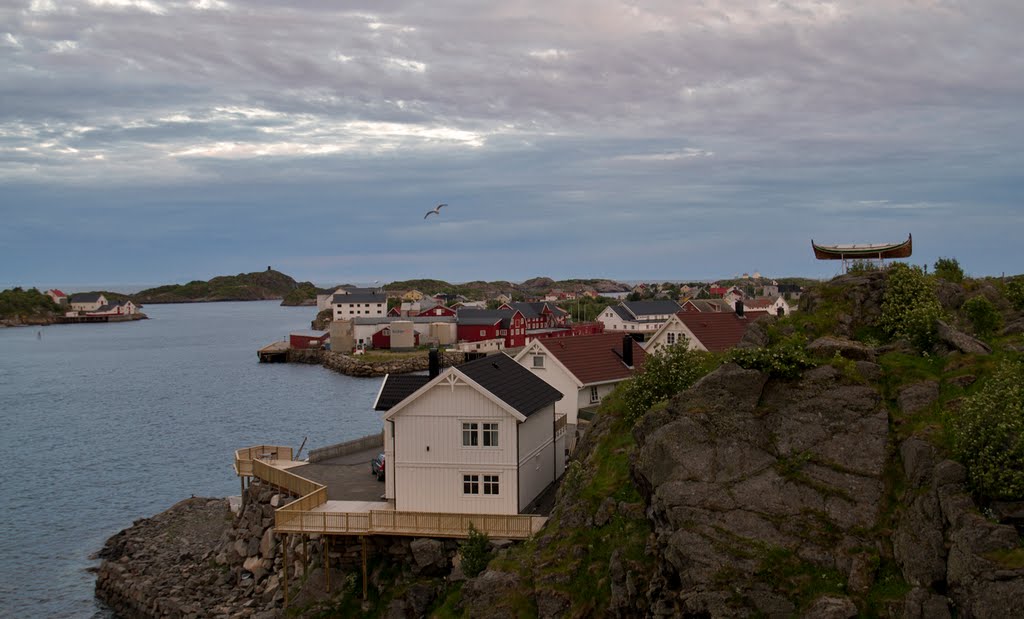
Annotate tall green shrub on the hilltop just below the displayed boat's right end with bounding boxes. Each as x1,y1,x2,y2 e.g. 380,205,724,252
879,262,943,352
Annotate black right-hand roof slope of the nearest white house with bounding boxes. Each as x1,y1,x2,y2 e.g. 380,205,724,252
456,353,562,417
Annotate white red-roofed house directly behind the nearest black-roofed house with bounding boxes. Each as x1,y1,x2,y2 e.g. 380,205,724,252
515,333,646,450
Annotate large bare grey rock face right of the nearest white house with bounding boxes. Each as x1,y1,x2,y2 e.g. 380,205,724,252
634,365,888,617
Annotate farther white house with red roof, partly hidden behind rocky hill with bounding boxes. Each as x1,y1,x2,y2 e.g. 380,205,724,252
644,301,768,355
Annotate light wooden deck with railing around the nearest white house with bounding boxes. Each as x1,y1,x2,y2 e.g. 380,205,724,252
234,445,548,539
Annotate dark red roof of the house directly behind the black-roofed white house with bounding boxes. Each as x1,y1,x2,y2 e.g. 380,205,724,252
544,333,647,384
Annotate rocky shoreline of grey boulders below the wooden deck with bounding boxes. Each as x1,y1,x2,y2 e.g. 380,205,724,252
96,481,475,619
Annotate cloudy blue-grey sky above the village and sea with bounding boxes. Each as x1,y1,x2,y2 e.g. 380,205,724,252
0,0,1024,291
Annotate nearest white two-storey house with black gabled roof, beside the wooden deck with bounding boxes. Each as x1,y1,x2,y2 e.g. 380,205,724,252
374,355,565,514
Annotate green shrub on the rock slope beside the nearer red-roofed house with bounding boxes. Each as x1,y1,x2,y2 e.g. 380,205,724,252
618,339,714,421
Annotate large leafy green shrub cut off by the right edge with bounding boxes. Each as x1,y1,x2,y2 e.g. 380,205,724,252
949,361,1024,500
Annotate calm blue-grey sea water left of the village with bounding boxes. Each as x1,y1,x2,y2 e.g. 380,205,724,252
0,301,380,617
